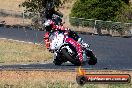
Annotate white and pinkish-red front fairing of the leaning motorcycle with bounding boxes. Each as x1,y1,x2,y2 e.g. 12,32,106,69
49,31,83,61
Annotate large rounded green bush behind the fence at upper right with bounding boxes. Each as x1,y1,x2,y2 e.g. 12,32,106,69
70,0,130,21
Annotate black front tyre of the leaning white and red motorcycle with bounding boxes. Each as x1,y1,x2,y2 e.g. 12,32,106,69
62,48,81,66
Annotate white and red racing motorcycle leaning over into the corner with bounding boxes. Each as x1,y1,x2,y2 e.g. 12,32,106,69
44,20,97,66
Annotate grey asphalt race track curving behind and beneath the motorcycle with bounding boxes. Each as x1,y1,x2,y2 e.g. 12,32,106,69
0,28,132,70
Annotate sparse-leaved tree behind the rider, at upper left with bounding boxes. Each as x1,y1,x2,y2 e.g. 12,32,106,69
20,0,68,28
